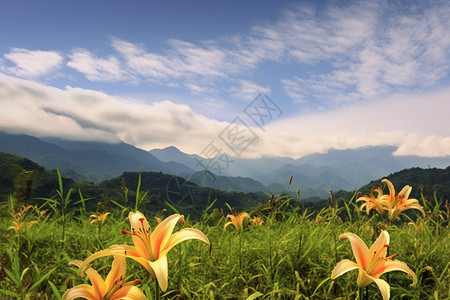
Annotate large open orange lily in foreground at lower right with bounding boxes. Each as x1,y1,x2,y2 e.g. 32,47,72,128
331,230,417,300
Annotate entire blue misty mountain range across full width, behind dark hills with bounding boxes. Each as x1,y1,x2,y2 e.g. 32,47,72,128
0,132,450,198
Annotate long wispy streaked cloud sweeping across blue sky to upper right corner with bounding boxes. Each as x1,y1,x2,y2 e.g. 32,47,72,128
54,1,450,108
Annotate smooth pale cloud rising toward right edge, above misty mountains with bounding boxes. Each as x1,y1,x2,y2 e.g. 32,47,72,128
255,89,450,157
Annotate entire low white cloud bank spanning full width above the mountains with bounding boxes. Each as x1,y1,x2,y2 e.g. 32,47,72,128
0,75,450,158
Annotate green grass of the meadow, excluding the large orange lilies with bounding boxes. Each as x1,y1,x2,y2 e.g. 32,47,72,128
0,175,450,299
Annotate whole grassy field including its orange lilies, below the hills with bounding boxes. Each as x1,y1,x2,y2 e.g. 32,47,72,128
0,176,450,299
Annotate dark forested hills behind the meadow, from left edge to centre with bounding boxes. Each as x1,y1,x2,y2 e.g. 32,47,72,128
0,152,267,215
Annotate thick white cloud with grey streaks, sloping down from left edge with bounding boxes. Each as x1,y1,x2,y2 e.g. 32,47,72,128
0,74,226,153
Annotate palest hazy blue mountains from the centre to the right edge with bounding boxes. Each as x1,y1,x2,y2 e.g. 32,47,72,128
151,146,450,198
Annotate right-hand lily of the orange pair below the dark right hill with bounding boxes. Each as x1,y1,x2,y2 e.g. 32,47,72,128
382,179,425,221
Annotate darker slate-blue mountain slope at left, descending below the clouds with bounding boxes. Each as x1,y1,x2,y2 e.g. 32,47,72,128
0,132,193,182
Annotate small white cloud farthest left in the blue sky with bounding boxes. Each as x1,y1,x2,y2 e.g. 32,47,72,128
4,48,63,78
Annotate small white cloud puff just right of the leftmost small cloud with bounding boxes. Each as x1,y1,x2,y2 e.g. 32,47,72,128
67,49,132,82
